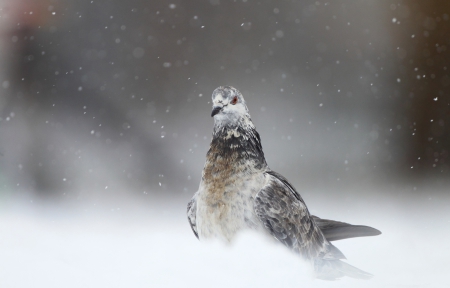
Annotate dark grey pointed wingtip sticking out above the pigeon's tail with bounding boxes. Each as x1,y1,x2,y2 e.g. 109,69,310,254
311,216,381,241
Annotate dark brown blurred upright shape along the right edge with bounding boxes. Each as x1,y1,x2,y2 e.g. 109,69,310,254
391,1,450,177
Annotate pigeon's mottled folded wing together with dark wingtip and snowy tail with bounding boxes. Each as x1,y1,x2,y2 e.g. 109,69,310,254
255,171,381,280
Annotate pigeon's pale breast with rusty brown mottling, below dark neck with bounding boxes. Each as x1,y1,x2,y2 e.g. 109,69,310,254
197,155,264,241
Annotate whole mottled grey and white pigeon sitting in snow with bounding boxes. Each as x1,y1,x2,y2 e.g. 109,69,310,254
187,86,381,280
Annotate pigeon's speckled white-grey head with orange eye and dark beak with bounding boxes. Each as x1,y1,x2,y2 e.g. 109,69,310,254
211,86,249,124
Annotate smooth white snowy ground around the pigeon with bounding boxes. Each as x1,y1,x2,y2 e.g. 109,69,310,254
0,183,450,288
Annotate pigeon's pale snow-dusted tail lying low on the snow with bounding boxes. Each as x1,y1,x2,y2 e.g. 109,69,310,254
314,259,373,281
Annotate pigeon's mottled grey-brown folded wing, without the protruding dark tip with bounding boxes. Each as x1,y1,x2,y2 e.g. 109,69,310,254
254,171,345,259
